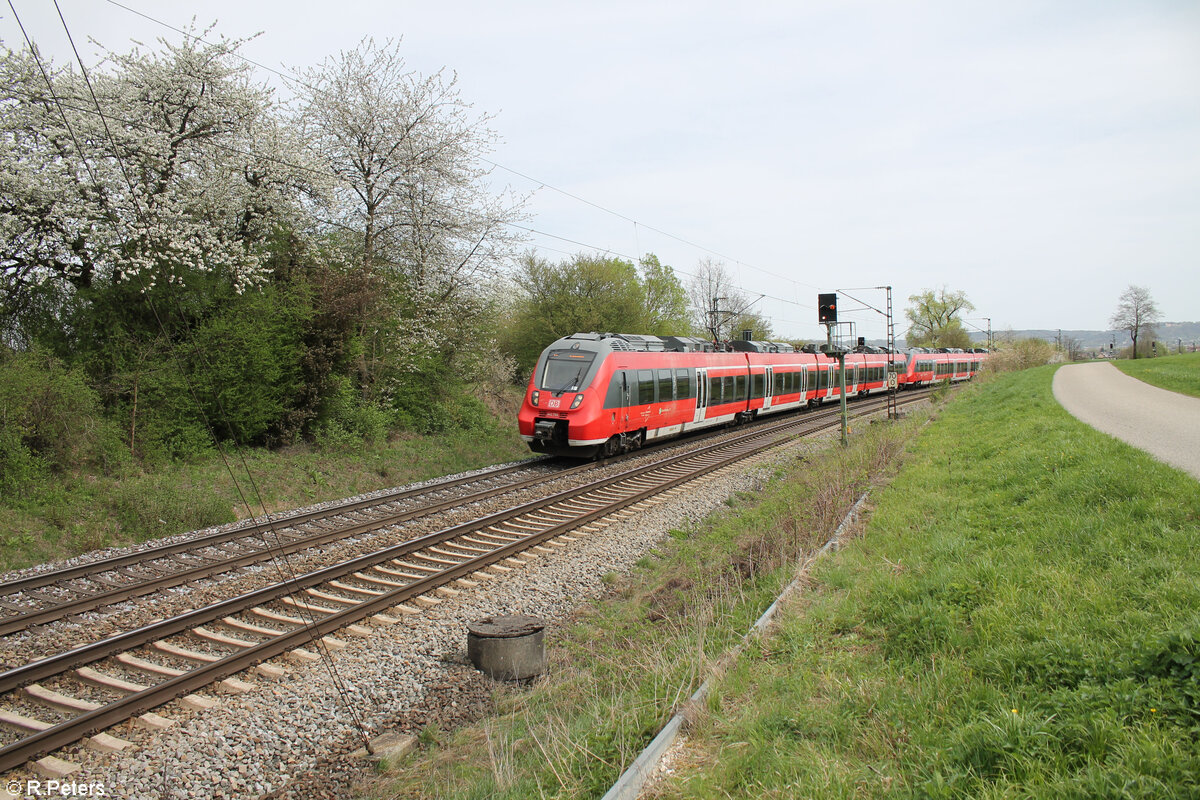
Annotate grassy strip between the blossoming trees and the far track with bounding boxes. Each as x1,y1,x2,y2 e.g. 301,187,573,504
0,413,529,570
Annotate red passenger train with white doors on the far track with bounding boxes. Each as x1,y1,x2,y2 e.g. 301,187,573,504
518,333,985,458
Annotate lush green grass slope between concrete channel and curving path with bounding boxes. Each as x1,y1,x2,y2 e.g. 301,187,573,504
656,368,1200,798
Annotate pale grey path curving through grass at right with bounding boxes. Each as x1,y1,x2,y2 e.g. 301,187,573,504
1054,362,1200,479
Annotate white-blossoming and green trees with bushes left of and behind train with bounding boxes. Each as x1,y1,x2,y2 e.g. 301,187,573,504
0,30,769,489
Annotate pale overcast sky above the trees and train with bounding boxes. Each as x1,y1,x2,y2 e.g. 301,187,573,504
0,0,1200,338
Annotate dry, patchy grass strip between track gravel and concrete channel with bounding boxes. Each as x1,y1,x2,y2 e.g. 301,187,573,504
364,407,919,800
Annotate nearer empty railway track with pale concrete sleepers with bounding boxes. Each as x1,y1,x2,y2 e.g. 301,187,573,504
0,393,923,771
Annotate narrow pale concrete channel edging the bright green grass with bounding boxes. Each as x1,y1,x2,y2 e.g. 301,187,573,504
601,492,868,800
